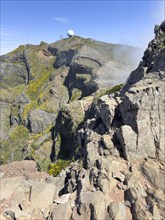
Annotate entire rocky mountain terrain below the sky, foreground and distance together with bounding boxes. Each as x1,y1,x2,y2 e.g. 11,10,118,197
0,21,165,220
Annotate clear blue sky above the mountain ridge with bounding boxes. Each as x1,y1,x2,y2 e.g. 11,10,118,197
1,0,165,54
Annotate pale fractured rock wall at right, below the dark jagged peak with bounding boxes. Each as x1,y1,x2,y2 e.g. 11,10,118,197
119,79,165,161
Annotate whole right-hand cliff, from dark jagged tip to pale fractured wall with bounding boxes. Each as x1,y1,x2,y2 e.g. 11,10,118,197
116,22,165,162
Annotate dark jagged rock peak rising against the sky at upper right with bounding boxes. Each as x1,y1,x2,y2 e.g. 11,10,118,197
123,21,165,92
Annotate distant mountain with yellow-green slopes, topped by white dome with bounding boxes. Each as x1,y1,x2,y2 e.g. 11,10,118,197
0,36,141,163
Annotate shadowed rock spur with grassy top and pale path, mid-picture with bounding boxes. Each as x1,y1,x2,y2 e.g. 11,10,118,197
53,96,93,160
